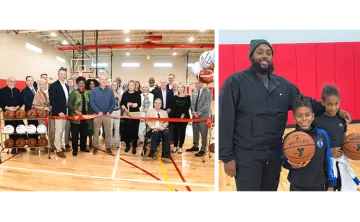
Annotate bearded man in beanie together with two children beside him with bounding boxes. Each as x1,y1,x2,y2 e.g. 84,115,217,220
217,39,359,192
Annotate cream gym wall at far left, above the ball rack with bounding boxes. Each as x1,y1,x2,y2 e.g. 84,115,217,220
0,33,70,82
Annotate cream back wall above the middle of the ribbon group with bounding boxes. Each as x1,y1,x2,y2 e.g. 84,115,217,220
90,55,212,86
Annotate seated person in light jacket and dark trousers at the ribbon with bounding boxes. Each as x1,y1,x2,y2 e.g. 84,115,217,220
146,98,170,159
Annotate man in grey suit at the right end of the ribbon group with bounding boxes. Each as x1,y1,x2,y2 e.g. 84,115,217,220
186,80,212,156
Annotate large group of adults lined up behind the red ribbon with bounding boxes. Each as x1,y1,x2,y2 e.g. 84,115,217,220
0,67,212,158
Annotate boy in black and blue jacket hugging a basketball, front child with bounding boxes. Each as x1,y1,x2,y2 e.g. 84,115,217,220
283,95,334,192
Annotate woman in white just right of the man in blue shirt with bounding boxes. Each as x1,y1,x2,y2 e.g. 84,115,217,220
110,82,121,148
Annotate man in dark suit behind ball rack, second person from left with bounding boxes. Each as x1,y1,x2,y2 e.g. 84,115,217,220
21,76,38,147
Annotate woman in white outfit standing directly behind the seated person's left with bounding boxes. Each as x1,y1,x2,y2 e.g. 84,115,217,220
139,83,154,143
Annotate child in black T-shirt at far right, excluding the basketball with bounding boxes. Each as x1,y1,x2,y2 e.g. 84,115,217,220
314,85,359,192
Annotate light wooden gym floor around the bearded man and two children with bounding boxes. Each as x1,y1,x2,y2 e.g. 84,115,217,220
217,124,360,192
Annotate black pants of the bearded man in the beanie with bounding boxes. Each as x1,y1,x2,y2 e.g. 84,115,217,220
235,145,282,192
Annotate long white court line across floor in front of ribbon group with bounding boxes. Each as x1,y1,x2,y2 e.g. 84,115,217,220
0,165,215,187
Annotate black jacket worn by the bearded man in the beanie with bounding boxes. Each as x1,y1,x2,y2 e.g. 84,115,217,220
216,67,324,163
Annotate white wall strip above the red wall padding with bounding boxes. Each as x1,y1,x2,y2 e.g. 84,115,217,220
216,24,360,44
